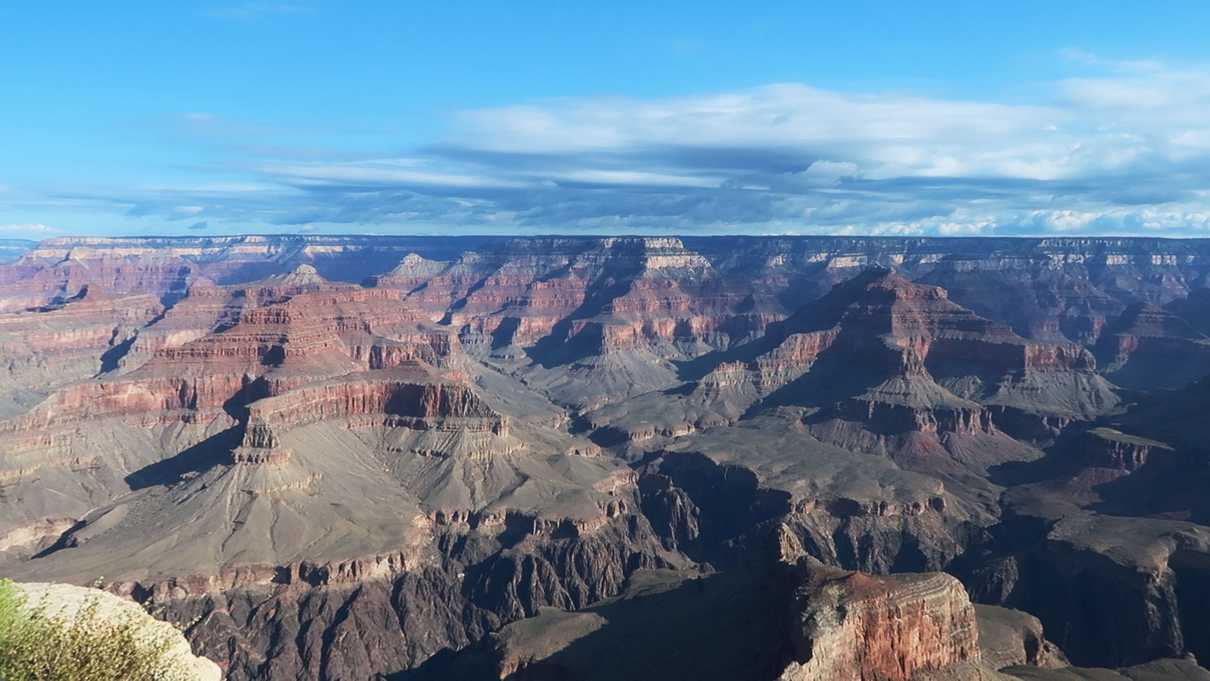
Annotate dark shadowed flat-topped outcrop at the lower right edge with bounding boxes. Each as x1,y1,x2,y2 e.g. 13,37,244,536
968,515,1210,666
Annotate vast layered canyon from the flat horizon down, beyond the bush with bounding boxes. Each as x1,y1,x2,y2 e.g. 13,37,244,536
0,235,1210,681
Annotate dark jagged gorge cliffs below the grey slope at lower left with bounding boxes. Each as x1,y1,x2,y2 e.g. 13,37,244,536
145,518,666,679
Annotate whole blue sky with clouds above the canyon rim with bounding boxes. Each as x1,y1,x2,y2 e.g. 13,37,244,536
0,0,1210,238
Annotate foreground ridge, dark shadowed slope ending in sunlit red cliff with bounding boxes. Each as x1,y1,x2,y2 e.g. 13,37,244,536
392,566,1008,681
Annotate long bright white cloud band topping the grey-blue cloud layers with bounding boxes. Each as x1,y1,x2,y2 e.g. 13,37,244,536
456,83,1066,177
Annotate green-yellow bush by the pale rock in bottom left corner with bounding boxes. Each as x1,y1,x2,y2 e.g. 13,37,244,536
0,579,189,681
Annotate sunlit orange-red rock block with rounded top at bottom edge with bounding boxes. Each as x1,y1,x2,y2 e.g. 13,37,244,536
779,571,979,681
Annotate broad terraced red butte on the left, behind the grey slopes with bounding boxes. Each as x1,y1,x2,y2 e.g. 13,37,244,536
7,290,457,440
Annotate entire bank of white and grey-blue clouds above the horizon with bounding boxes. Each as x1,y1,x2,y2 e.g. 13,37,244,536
30,51,1210,236
